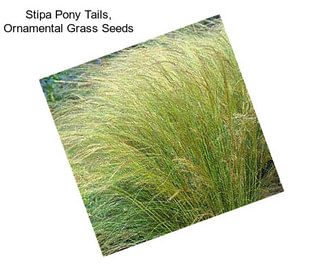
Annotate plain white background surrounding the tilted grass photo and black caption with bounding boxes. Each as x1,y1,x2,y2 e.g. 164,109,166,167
0,0,323,271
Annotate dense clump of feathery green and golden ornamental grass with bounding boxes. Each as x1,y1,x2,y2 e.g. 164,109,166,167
46,20,281,255
